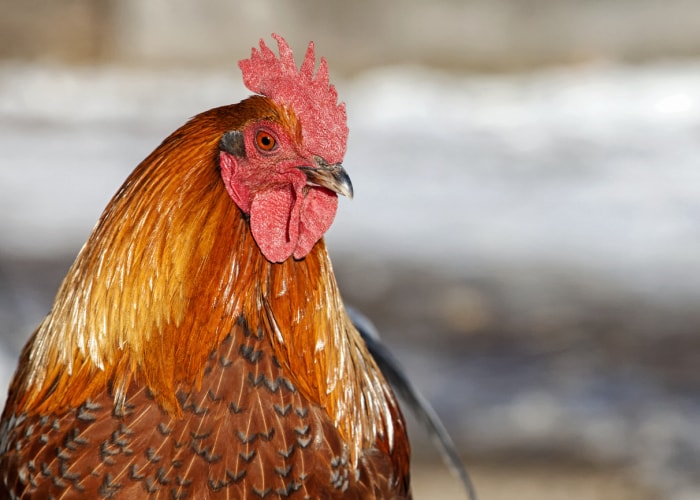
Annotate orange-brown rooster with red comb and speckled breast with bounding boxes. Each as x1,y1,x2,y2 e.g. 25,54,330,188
0,35,410,499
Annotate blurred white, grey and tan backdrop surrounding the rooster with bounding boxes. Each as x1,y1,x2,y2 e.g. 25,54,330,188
0,0,700,500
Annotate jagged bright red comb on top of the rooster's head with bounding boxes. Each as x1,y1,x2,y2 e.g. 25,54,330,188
238,33,348,163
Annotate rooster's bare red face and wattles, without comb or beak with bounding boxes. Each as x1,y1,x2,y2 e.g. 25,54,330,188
219,121,338,262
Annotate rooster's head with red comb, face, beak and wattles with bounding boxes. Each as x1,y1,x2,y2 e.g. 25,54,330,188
219,35,353,262
